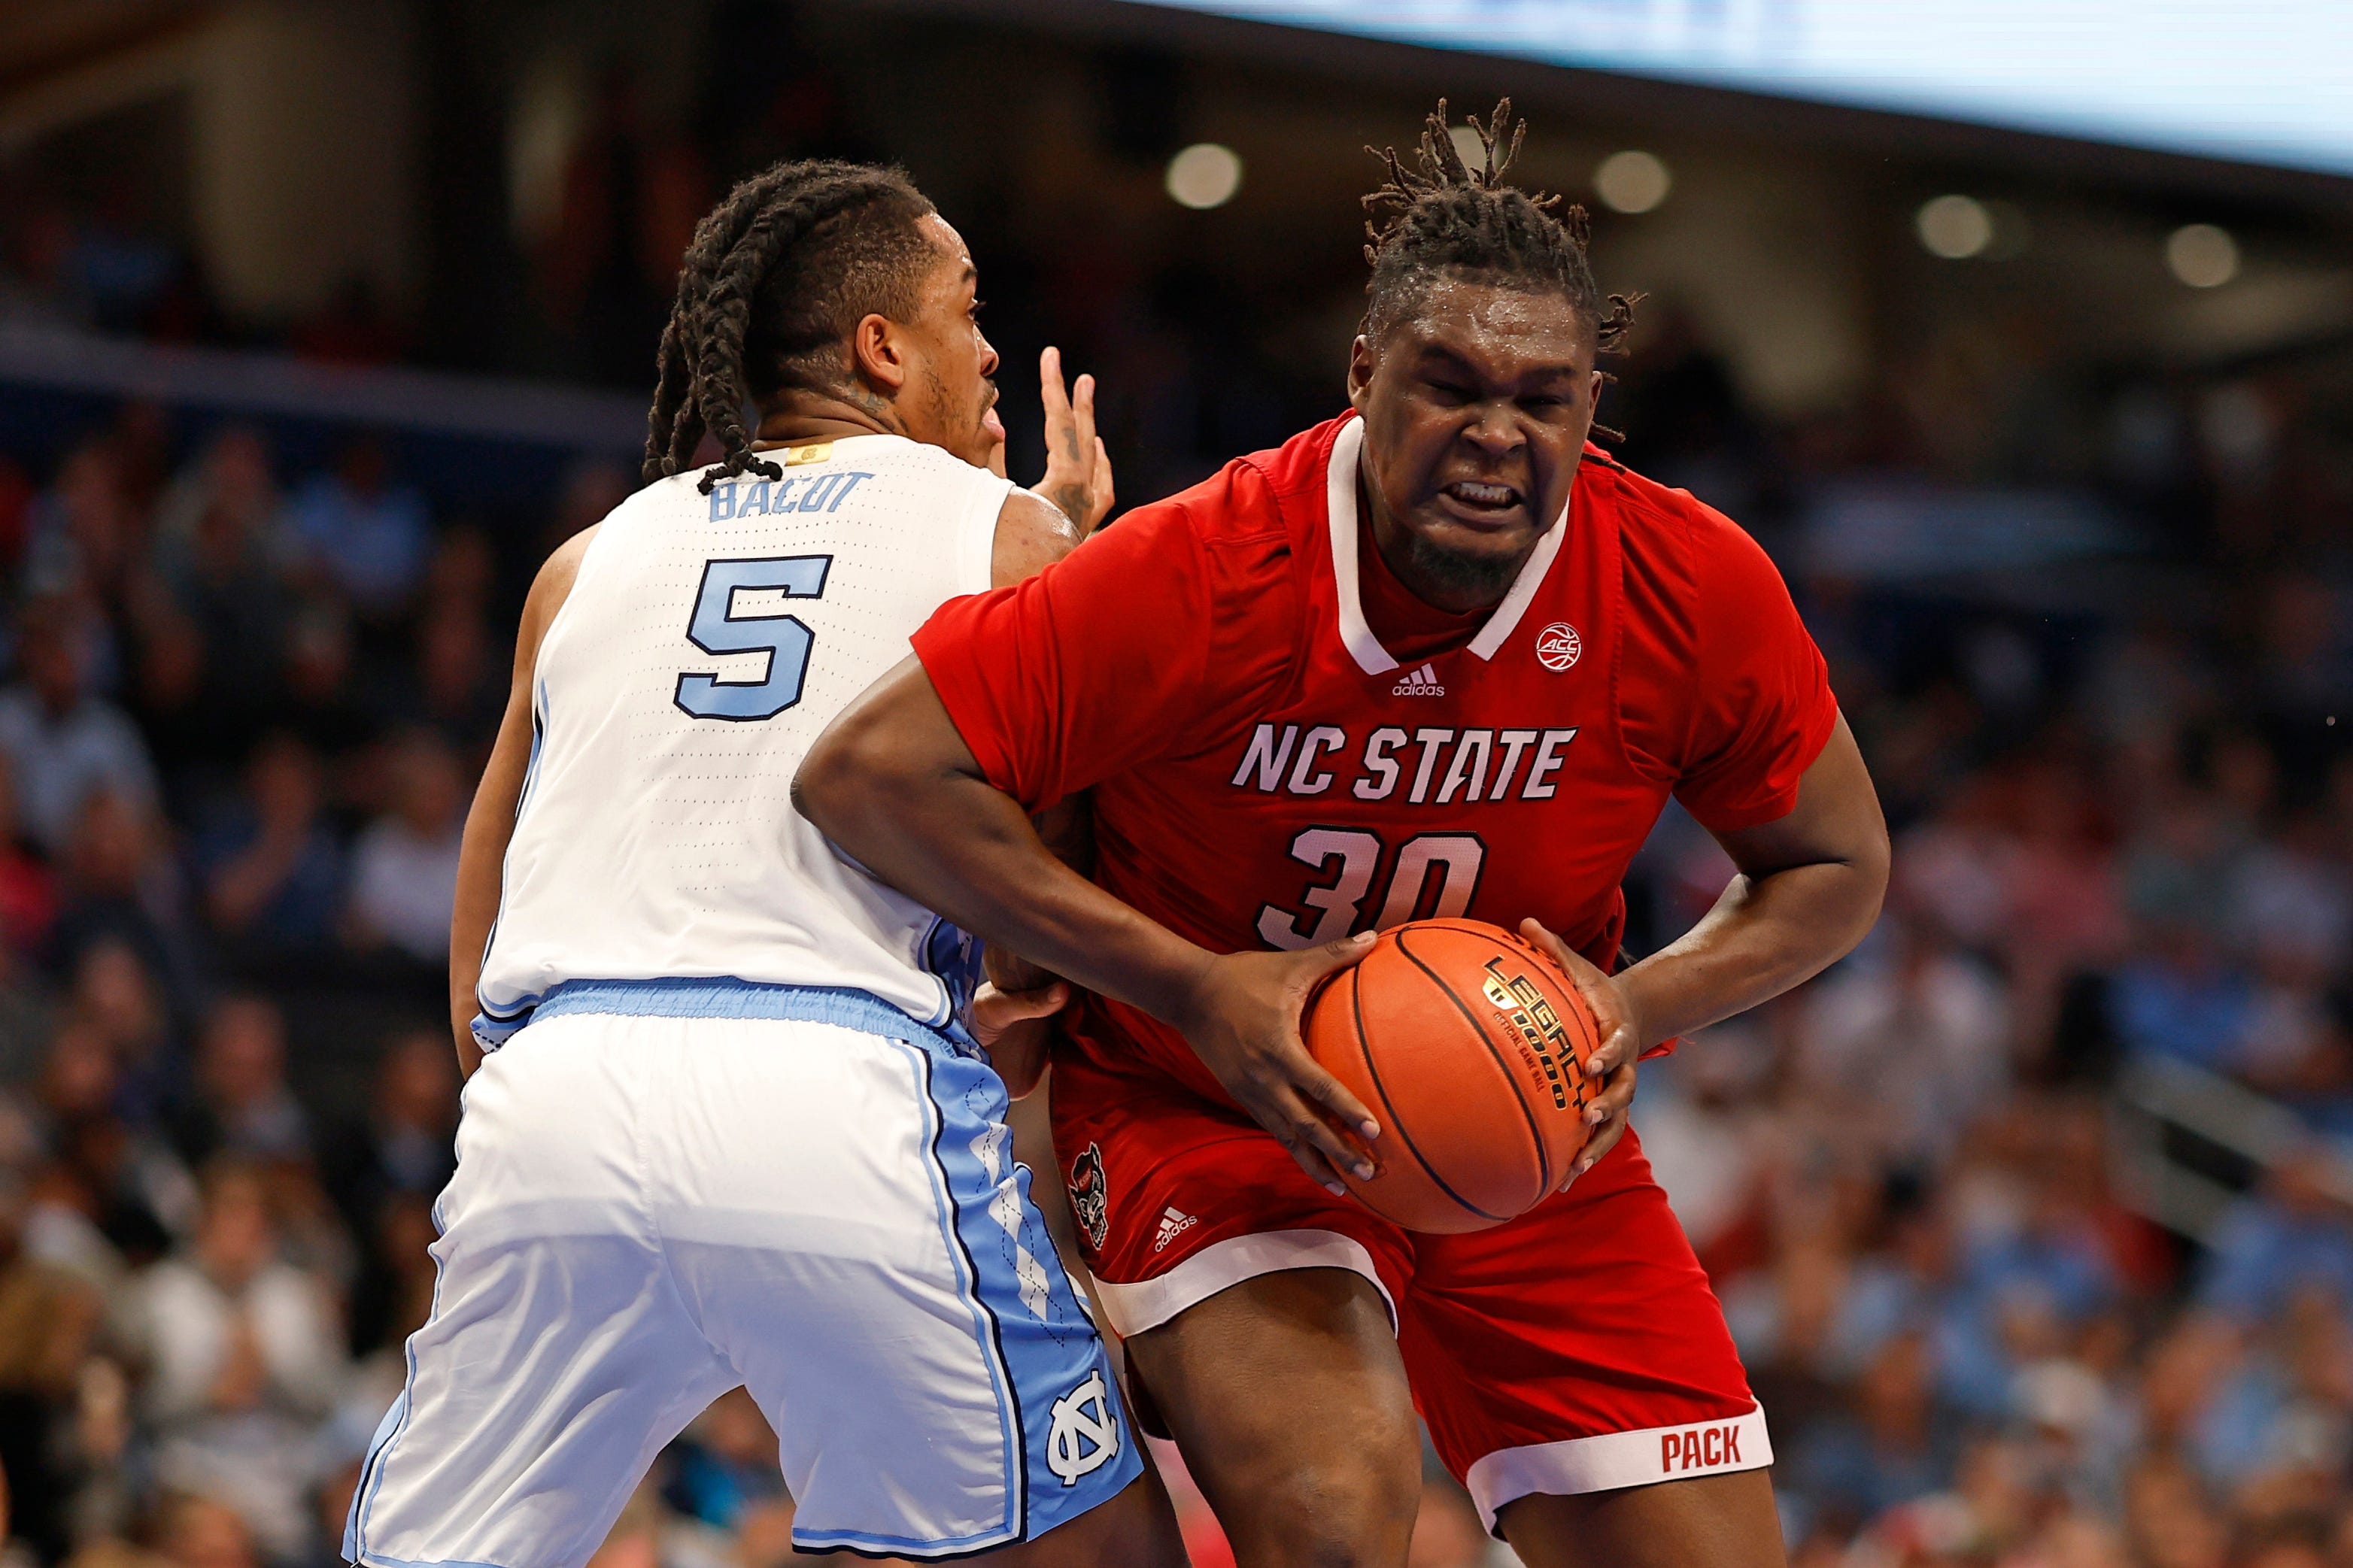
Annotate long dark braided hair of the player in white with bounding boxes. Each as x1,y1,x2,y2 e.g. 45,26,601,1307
642,160,932,493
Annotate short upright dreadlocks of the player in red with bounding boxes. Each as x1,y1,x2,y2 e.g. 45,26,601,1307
1365,99,1642,353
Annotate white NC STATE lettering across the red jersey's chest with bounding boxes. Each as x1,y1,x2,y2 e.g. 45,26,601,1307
1233,724,1577,806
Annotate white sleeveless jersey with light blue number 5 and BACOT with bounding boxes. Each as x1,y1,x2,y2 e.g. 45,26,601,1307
475,435,1012,1046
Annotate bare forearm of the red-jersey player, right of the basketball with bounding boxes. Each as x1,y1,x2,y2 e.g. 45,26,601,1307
1619,860,1885,1048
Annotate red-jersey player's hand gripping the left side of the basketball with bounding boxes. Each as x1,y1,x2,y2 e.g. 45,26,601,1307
1170,931,1381,1196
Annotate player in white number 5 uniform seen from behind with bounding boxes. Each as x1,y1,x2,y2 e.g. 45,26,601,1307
344,162,1183,1568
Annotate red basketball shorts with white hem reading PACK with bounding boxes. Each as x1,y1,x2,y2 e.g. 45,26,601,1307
1054,1053,1772,1530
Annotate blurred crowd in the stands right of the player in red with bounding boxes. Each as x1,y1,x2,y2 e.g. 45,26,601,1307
1629,350,2353,1568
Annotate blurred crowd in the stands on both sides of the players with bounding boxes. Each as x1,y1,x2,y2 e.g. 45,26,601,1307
0,395,2353,1568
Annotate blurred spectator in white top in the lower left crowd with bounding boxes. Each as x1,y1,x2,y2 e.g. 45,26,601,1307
123,1163,344,1563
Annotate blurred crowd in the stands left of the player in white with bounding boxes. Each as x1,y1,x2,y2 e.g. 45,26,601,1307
0,405,687,1568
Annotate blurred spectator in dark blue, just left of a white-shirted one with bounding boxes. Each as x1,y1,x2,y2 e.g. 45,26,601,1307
190,733,344,954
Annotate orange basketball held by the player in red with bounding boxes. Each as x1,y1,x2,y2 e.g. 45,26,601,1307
1304,919,1600,1232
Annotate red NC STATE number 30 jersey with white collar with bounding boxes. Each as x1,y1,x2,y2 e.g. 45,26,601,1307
915,416,1838,1100
